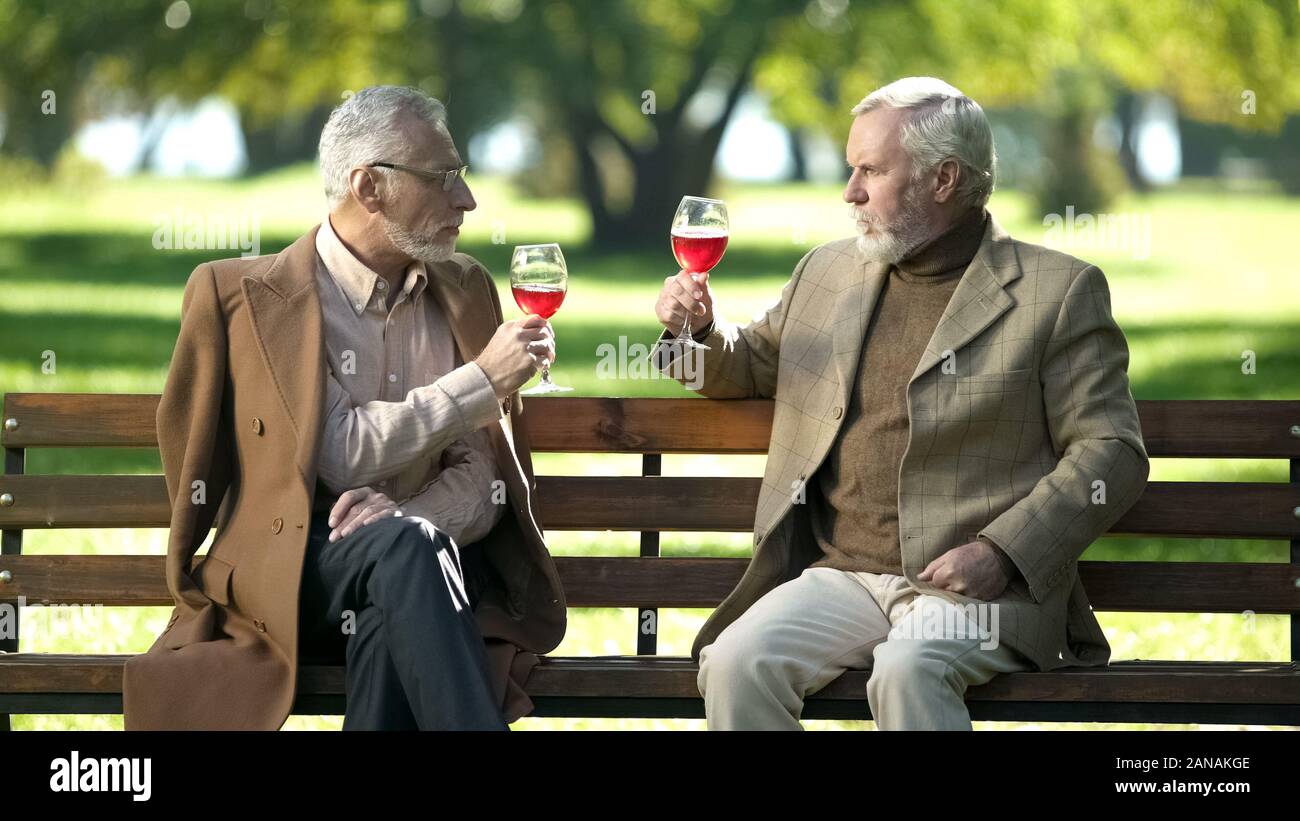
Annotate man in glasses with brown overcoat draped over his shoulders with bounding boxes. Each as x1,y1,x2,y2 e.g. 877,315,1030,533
124,86,566,729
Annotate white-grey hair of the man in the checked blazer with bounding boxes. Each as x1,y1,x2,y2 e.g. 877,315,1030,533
853,77,997,207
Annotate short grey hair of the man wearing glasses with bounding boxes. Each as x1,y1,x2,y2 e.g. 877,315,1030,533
320,86,447,208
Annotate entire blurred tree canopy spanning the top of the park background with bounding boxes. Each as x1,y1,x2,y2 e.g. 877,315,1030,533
0,0,1300,237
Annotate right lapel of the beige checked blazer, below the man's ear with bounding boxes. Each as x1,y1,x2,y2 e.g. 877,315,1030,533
909,217,1021,383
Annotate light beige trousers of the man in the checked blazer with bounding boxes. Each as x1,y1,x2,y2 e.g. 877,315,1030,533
698,568,1034,730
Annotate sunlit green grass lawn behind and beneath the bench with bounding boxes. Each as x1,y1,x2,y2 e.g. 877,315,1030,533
0,168,1300,729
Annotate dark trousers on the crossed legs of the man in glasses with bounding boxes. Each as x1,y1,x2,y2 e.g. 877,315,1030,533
299,512,507,730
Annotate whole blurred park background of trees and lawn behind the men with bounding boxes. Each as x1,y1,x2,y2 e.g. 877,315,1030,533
0,0,1300,729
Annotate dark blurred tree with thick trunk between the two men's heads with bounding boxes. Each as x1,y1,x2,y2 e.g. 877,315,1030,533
412,0,803,246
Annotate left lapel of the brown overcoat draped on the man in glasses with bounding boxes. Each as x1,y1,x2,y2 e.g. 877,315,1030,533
242,226,325,490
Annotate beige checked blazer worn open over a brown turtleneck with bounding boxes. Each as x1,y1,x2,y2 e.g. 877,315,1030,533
657,214,1148,670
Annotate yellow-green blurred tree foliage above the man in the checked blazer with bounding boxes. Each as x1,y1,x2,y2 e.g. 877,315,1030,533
755,0,1300,212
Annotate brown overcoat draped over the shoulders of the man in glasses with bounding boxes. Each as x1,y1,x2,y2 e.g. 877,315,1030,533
122,229,566,730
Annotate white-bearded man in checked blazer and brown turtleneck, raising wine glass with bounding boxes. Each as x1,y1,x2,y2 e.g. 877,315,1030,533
657,78,1148,730
